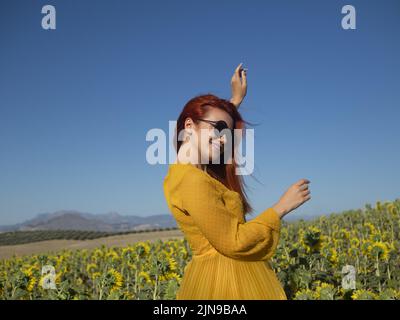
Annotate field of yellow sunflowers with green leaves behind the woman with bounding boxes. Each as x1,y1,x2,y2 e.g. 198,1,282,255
0,199,400,300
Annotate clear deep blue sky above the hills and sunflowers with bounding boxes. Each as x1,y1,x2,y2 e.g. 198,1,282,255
0,0,400,224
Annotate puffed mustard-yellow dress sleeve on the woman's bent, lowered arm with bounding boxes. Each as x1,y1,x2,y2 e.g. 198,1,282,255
177,170,281,261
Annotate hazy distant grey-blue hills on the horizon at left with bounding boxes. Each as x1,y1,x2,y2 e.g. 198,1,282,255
0,210,177,232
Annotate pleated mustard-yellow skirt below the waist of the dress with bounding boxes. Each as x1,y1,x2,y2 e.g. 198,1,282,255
176,253,287,300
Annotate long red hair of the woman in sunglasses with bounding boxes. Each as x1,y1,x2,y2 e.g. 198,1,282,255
174,94,253,214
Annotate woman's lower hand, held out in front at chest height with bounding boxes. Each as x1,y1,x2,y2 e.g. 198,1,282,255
273,179,311,218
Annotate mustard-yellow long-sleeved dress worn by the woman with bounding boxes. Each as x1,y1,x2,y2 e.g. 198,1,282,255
163,163,287,300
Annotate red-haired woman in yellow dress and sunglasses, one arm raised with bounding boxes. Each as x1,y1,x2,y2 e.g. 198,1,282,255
163,64,310,300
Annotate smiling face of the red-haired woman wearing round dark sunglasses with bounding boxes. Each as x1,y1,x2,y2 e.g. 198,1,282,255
185,108,234,163
